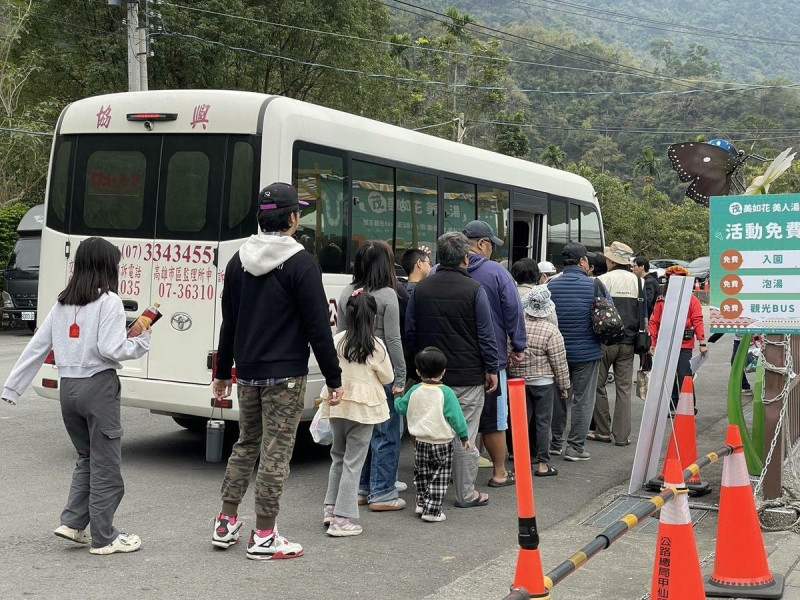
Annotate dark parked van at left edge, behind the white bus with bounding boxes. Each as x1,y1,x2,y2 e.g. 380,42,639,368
3,204,44,331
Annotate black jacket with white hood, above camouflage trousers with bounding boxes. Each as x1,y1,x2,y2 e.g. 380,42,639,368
216,236,342,388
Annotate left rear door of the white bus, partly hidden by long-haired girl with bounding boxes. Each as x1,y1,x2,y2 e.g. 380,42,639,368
70,135,161,377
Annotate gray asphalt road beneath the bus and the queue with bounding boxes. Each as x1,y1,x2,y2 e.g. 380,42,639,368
0,324,731,600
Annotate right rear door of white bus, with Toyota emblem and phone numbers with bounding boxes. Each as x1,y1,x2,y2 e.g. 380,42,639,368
147,134,227,384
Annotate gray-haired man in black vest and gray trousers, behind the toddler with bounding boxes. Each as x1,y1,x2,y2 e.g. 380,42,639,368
406,232,496,508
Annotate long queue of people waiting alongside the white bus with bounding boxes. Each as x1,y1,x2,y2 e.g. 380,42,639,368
2,182,705,560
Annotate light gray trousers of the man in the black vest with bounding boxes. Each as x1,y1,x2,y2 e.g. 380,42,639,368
446,385,486,502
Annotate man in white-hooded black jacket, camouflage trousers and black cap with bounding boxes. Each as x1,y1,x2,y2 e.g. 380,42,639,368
212,183,342,560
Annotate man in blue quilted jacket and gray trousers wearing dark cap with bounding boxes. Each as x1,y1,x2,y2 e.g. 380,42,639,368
547,242,611,461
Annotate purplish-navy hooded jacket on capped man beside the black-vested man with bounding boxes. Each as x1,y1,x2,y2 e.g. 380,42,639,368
467,254,527,369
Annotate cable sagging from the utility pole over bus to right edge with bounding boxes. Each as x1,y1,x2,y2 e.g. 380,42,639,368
149,27,800,96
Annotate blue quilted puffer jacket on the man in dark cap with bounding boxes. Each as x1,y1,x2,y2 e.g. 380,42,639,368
547,265,610,364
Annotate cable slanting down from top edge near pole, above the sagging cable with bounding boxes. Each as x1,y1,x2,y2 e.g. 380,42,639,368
163,1,750,86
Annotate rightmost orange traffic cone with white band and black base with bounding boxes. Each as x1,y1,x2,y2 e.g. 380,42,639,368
706,425,783,598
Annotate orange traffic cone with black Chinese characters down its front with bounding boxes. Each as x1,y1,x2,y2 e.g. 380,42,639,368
650,459,706,600
